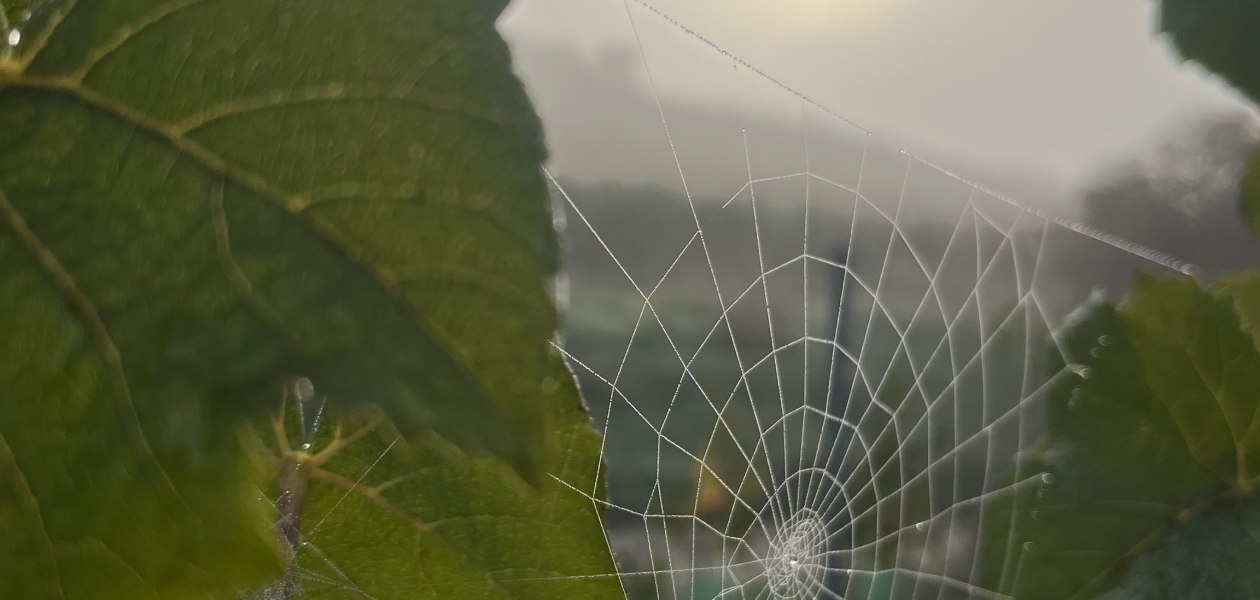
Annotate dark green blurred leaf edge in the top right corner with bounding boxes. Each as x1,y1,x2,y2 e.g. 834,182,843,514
1159,0,1260,103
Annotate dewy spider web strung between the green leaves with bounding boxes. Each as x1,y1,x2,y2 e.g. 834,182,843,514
536,0,1192,600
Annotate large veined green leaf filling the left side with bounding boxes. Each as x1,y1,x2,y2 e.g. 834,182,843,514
0,0,606,599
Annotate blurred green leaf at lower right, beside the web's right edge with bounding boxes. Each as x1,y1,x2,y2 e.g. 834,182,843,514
984,275,1260,599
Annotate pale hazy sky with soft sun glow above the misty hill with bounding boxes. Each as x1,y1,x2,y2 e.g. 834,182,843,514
500,0,1242,190
